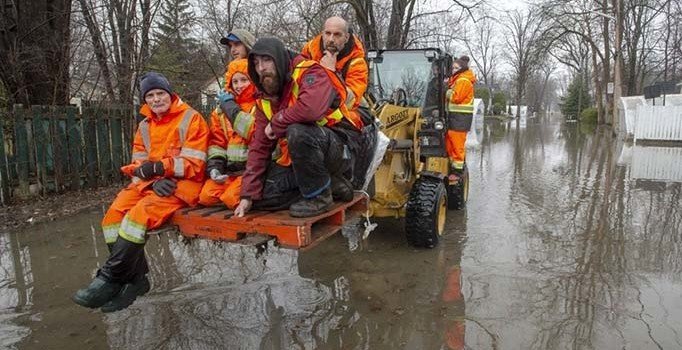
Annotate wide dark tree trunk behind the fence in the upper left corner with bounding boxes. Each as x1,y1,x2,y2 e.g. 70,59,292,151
0,0,71,105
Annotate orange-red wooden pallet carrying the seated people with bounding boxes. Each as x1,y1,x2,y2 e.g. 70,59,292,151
171,194,366,249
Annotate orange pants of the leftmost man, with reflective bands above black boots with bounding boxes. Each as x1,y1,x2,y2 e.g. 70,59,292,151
102,186,187,244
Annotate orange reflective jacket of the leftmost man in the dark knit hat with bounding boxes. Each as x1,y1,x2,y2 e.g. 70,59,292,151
121,94,209,205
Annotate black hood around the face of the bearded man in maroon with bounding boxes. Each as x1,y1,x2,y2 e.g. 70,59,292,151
249,38,293,93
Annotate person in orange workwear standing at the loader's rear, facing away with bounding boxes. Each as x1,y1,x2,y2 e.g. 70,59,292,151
445,56,476,180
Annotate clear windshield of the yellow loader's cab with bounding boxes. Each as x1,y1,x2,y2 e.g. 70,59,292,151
370,51,432,107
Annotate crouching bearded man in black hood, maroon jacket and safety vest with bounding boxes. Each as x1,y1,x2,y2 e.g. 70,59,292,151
235,38,362,217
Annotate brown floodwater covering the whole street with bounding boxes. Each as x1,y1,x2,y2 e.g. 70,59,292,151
0,119,682,349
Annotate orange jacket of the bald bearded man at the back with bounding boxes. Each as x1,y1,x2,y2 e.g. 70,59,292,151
301,34,369,110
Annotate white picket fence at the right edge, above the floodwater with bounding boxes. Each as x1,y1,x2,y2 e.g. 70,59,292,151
633,105,682,142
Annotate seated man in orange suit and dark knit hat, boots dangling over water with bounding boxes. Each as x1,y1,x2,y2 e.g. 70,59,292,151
72,72,209,312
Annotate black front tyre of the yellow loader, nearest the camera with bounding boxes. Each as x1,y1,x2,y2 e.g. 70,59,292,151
405,176,448,248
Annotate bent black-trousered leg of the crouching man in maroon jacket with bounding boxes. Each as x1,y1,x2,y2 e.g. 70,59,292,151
287,124,351,198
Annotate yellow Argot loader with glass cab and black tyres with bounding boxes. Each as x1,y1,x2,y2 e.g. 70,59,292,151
367,48,468,247
